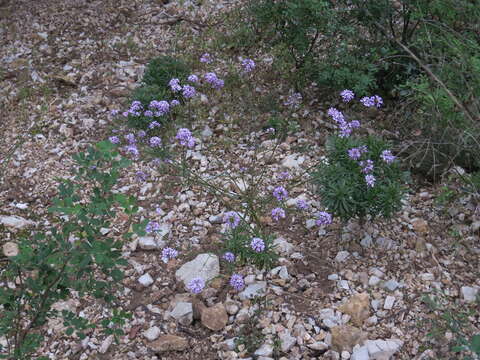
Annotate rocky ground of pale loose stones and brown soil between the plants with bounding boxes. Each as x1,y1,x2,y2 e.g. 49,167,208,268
0,0,480,360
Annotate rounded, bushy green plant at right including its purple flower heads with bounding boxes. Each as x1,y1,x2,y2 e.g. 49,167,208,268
312,91,406,223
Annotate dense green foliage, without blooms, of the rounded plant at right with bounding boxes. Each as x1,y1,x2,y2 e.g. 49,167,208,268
312,136,405,221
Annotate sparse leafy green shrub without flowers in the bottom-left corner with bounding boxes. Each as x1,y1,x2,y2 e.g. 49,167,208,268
0,142,141,360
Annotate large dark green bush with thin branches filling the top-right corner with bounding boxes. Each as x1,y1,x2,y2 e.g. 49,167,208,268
242,0,480,178
